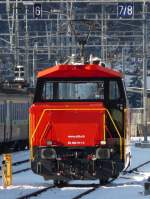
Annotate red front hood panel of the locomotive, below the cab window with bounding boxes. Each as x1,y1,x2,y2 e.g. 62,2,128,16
30,102,105,146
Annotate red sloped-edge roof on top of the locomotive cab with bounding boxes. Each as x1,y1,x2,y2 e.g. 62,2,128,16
37,64,122,78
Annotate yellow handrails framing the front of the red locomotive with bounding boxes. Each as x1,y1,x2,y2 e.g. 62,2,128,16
30,108,122,160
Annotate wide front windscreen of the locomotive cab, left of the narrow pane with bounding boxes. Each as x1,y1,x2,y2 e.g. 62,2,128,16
34,81,104,101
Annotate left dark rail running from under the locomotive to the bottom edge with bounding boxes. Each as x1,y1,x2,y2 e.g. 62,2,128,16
16,185,56,199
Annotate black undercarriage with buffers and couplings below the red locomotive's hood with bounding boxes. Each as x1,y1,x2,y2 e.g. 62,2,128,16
31,147,124,183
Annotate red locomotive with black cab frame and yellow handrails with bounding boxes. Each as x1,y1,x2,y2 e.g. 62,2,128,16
30,56,130,184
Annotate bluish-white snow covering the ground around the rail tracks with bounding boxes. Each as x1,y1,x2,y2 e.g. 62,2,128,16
0,142,150,199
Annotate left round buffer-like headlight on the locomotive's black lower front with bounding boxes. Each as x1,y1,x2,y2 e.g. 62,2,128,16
41,148,57,159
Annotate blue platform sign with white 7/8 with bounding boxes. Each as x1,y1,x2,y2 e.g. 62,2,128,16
117,2,134,18
